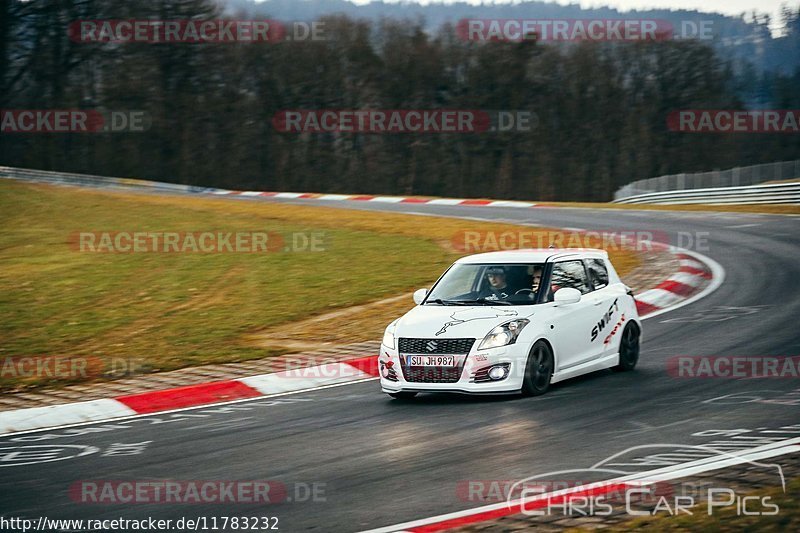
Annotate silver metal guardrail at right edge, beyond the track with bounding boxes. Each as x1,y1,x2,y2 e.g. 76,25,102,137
614,182,800,205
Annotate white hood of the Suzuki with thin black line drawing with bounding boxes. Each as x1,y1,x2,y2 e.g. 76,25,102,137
395,305,533,339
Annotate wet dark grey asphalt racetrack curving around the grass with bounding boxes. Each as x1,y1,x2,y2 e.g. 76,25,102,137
0,199,800,532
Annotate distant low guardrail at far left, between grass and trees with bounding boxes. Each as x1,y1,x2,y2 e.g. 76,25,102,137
0,167,220,193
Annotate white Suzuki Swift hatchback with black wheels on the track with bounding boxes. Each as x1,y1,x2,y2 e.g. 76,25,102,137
378,249,642,398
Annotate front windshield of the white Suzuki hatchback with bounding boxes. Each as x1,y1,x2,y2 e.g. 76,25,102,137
425,263,544,305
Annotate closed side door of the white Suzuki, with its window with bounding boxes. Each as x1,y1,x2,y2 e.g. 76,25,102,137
547,259,602,371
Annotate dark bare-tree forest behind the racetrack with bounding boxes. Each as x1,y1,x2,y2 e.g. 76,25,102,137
0,0,800,200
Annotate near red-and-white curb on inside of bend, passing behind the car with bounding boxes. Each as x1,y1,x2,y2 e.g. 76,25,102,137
0,249,725,435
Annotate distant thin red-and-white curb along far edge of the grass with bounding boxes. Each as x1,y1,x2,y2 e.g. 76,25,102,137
211,189,543,207
